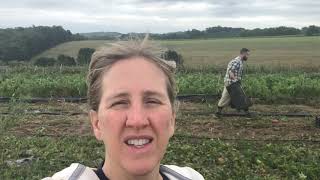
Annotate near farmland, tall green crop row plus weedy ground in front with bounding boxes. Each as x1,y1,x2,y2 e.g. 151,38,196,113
0,68,320,179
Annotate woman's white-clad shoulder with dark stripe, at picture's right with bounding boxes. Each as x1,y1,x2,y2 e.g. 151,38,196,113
160,165,204,180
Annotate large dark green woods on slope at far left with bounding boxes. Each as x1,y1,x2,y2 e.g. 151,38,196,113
0,26,84,62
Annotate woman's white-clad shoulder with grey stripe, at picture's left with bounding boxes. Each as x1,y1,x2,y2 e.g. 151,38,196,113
42,163,99,180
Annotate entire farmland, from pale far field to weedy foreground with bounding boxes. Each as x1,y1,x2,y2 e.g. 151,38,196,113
0,36,320,180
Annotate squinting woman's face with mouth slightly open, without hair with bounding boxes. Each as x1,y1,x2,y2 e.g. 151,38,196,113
91,57,175,175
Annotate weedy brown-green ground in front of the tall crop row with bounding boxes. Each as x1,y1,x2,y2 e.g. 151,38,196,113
0,102,320,179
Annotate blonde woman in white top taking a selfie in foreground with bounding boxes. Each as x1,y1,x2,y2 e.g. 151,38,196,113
43,37,204,180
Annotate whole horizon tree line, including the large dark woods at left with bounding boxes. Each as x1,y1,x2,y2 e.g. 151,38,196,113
0,25,320,63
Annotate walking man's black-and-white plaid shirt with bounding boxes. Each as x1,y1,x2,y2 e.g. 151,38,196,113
224,56,243,86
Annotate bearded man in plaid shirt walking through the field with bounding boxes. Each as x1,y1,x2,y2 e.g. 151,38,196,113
216,48,250,115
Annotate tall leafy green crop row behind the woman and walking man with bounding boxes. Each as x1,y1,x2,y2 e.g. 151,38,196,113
0,72,320,99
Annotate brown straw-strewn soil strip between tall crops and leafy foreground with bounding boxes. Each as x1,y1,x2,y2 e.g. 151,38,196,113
0,102,320,142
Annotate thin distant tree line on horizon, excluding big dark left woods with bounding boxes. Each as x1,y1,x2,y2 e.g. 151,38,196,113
89,25,320,40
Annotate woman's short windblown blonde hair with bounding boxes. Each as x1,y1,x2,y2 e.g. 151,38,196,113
87,35,177,111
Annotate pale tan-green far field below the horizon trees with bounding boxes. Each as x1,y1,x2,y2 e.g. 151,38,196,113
34,36,320,67
